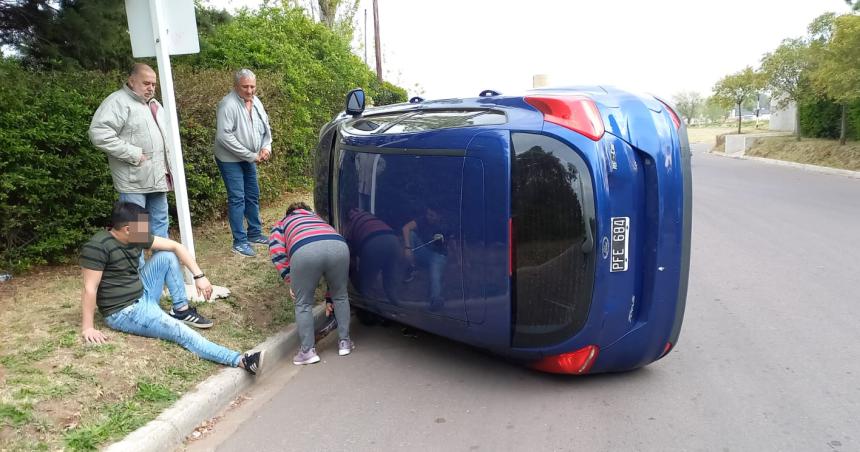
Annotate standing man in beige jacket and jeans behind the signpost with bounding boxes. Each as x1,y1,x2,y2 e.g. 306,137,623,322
89,63,173,242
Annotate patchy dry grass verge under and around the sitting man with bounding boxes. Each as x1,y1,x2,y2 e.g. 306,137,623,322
0,192,311,450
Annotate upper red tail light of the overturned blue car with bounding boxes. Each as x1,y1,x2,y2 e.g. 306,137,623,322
525,95,605,141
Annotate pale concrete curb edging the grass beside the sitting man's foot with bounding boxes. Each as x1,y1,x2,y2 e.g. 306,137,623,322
104,306,325,452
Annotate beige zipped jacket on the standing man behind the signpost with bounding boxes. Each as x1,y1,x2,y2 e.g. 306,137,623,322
89,85,173,193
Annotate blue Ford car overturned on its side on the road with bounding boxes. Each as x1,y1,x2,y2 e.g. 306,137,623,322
314,86,692,374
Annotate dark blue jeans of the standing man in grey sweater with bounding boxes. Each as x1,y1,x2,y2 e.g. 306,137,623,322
215,159,263,246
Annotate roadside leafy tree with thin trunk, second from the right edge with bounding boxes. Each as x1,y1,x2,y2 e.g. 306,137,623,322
761,39,813,141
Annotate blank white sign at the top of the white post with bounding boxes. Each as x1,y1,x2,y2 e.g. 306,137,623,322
125,0,200,58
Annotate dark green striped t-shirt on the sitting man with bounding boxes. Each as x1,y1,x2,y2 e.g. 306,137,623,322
80,231,153,317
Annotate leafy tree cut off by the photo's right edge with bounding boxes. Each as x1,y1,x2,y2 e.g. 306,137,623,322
811,15,860,144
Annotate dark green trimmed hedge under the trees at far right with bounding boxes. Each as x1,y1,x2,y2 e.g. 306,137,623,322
800,98,860,140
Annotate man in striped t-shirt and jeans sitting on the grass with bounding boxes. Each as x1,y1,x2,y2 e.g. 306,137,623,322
80,202,263,375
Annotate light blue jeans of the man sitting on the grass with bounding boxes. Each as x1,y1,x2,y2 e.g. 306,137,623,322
105,251,242,367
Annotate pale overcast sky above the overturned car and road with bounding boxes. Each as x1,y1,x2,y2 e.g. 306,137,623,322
209,0,849,99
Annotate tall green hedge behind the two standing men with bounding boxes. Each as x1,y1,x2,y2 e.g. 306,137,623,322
0,8,406,271
